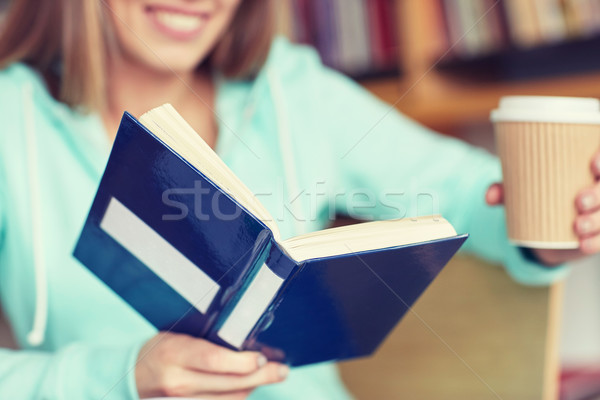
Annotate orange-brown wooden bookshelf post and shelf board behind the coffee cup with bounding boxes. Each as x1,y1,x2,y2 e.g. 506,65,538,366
363,0,600,131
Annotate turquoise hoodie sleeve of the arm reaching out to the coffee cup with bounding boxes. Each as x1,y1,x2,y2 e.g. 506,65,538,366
272,40,567,285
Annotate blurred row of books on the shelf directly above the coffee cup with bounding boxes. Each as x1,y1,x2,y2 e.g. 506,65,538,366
437,0,600,57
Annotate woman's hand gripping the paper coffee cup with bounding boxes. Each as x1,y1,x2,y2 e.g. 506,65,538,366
485,153,600,265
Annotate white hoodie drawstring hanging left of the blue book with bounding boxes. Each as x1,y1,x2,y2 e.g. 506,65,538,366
23,84,48,346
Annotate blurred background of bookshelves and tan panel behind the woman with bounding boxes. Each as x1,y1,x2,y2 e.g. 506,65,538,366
0,0,600,400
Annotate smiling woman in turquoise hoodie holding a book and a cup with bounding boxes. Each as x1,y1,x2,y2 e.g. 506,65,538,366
0,0,600,399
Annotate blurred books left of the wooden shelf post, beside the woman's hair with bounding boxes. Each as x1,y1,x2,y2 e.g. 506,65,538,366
277,0,399,78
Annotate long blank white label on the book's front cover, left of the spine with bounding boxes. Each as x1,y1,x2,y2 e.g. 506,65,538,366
100,197,220,314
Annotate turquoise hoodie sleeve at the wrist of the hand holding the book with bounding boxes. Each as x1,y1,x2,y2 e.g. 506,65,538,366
0,343,141,400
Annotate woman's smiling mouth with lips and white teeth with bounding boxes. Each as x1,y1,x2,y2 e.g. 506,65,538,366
146,6,208,40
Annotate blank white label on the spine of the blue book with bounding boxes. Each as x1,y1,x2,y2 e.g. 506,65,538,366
218,264,283,348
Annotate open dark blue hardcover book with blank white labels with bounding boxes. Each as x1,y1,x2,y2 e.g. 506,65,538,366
74,105,467,365
